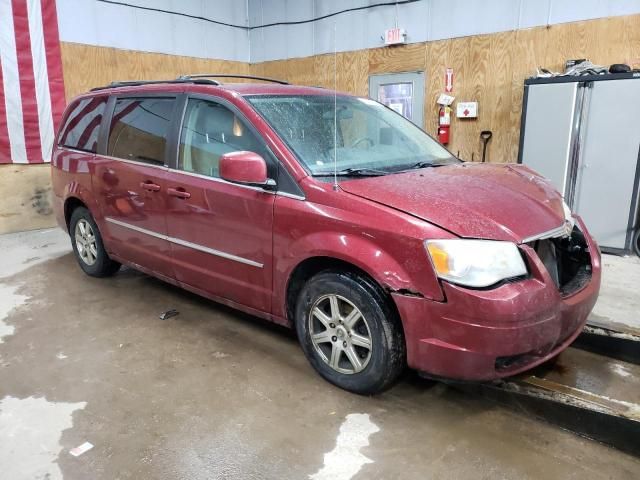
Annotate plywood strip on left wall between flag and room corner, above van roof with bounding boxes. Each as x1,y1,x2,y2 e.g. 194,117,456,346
61,42,249,100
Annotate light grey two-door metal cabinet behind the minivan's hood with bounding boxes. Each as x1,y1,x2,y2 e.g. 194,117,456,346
518,72,640,252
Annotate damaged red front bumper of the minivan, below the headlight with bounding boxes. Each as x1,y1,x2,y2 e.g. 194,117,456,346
393,218,601,381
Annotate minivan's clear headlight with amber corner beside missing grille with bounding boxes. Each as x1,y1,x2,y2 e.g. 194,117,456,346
425,239,527,287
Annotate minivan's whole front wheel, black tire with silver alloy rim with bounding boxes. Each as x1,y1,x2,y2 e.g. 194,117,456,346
295,271,406,395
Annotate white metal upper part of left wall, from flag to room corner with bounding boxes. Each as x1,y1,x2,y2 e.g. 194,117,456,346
57,0,249,62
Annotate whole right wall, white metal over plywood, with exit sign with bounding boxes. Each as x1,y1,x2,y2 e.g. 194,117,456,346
249,0,640,162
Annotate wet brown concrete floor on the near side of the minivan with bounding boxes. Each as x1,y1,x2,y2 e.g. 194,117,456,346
0,230,640,480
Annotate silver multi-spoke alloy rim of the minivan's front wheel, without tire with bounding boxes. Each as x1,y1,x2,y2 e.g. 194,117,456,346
308,294,372,374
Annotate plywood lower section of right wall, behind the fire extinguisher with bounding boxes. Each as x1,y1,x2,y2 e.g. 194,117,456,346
251,15,640,162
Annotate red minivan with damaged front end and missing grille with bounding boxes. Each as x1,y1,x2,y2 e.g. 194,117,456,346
52,76,601,394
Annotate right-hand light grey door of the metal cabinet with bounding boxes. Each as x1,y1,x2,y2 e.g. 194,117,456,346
574,79,640,249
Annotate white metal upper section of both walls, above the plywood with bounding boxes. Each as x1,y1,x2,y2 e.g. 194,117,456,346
57,0,640,62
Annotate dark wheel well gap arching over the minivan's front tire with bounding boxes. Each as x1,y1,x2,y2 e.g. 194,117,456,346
286,257,404,328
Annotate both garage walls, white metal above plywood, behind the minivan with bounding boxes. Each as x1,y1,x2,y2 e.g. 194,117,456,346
0,0,640,233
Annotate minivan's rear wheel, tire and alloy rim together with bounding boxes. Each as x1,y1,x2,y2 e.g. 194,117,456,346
69,207,120,277
